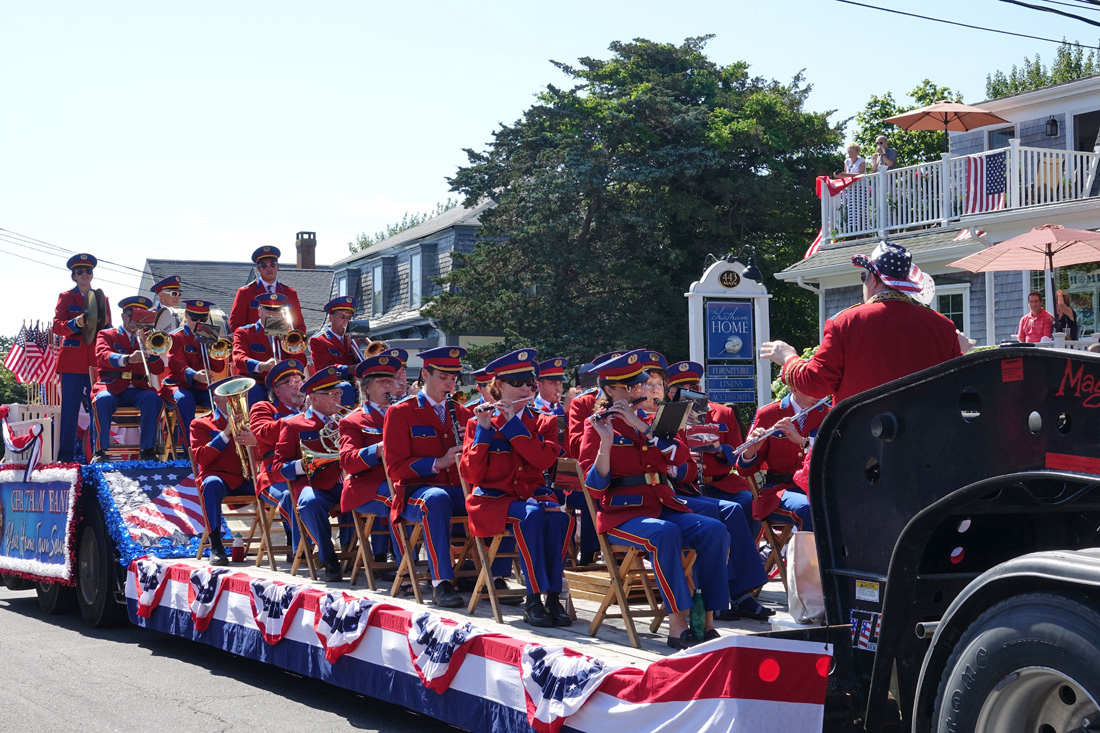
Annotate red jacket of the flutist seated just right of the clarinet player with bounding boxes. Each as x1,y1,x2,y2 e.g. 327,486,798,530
460,406,561,537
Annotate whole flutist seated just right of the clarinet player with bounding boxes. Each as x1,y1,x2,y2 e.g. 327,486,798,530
460,349,573,627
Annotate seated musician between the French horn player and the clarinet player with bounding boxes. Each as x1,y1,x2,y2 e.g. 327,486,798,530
340,355,400,562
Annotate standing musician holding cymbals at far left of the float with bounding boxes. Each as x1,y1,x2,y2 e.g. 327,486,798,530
53,254,111,463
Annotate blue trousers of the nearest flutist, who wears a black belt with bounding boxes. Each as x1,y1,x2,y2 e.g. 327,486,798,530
607,508,729,613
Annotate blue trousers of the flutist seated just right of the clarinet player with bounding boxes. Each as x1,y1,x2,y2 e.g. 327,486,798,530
503,501,573,595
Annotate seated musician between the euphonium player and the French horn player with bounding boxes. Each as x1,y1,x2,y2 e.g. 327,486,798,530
249,359,306,557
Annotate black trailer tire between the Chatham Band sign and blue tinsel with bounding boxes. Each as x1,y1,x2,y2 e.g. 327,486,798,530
76,510,127,628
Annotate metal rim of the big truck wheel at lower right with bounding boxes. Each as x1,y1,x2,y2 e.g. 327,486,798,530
975,667,1100,733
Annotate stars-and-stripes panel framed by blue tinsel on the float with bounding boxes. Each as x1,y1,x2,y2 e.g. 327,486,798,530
103,467,205,547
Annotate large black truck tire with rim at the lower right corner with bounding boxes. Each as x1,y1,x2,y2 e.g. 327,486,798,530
933,592,1100,733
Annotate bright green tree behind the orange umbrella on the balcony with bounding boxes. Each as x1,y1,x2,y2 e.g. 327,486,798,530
853,79,963,165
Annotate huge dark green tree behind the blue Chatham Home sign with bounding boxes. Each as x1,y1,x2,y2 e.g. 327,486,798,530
428,36,840,363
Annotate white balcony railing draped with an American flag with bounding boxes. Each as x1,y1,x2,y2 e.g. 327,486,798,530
821,140,1100,240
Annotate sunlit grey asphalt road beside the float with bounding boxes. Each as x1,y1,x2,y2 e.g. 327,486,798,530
0,584,458,733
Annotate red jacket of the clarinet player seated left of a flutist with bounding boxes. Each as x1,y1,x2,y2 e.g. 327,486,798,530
382,392,473,521
